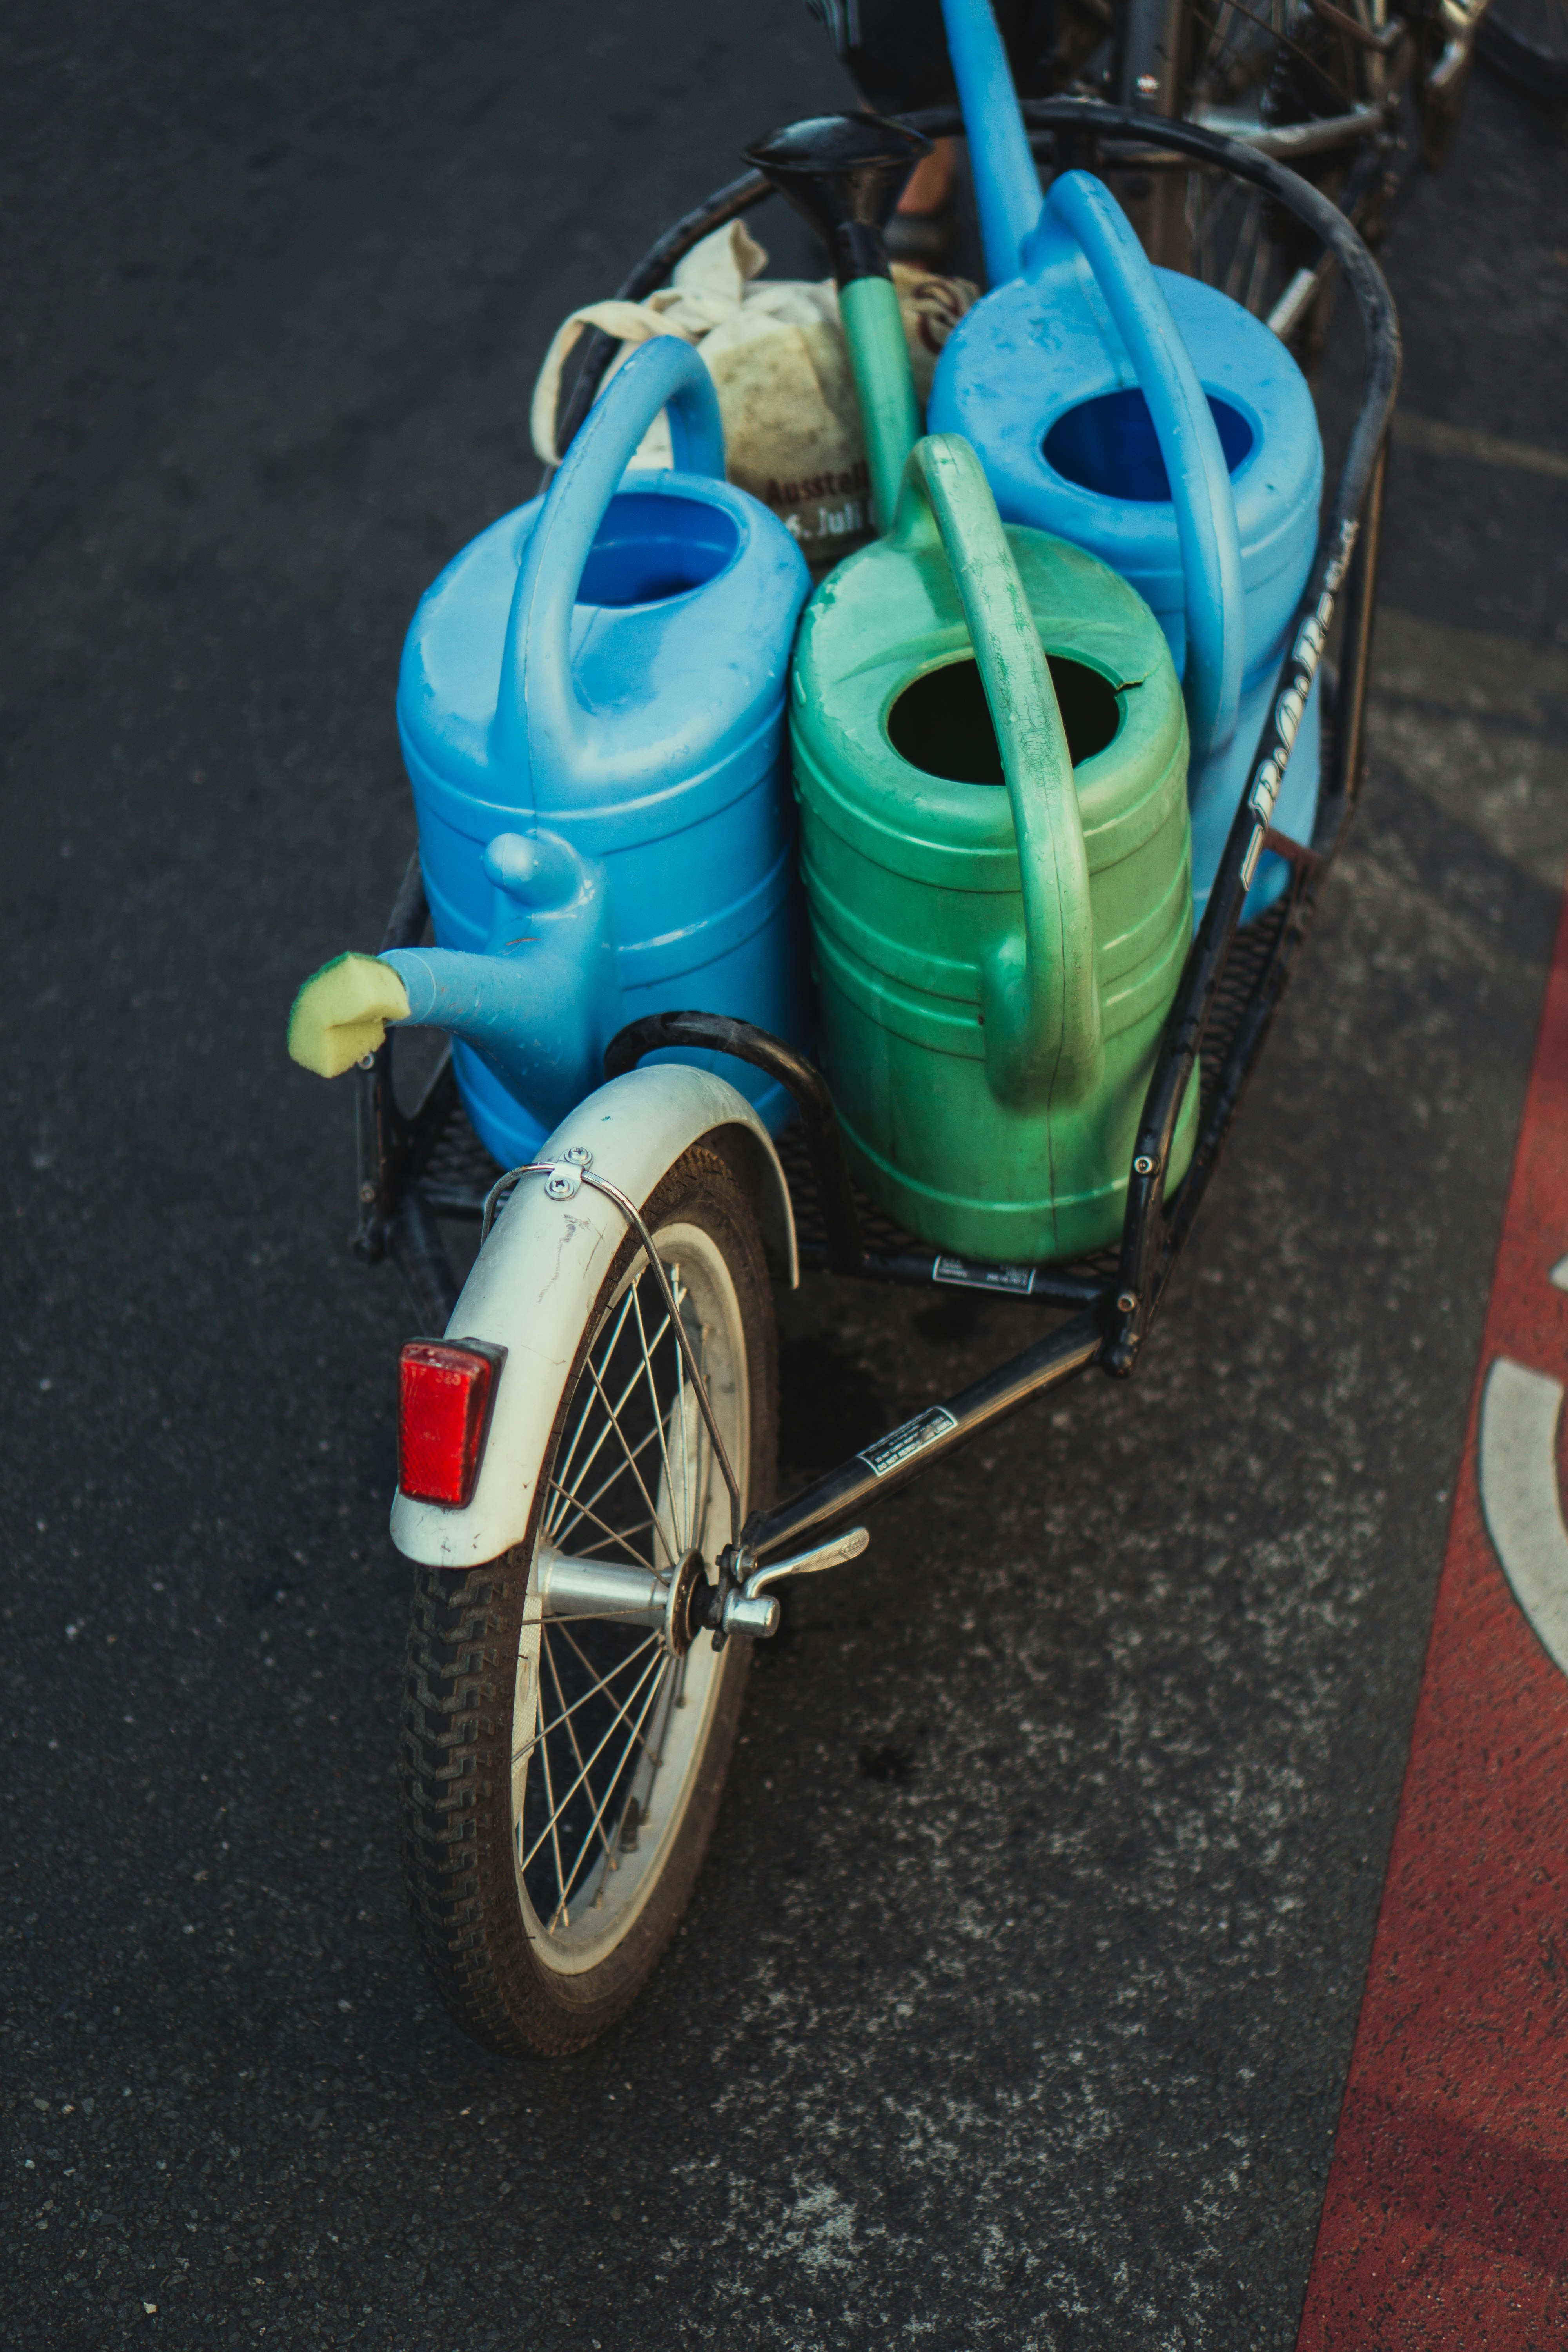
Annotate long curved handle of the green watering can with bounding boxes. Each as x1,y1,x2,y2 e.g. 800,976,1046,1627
891,433,1105,1108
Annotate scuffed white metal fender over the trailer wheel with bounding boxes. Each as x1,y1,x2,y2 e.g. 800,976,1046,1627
381,1063,797,1569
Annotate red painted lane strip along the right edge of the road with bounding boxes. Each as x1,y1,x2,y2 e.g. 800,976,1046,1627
1298,880,1568,2352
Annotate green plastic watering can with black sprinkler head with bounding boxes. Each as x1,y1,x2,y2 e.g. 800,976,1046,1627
748,118,1196,1263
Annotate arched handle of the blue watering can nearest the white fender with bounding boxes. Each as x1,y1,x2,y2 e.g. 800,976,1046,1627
496,334,724,774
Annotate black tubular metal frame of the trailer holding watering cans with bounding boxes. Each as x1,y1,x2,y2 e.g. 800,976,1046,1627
355,99,1399,1557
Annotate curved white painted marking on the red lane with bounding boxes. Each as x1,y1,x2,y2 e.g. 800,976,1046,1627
1481,1355,1568,1675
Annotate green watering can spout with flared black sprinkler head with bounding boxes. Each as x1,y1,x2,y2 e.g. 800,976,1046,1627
745,115,931,532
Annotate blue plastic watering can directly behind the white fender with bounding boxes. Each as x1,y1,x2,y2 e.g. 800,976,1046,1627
390,336,811,1167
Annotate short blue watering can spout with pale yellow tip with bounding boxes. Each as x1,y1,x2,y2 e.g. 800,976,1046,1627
289,833,623,1129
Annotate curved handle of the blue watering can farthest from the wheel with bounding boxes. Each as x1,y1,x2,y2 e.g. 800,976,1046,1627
1025,185,1246,776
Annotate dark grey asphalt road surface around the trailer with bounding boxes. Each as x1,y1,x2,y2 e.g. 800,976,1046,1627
0,0,1568,2352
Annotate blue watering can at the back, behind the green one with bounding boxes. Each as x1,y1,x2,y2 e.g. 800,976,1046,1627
926,0,1323,920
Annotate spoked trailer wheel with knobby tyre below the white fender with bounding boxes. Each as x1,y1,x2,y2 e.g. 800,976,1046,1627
402,1145,776,2056
